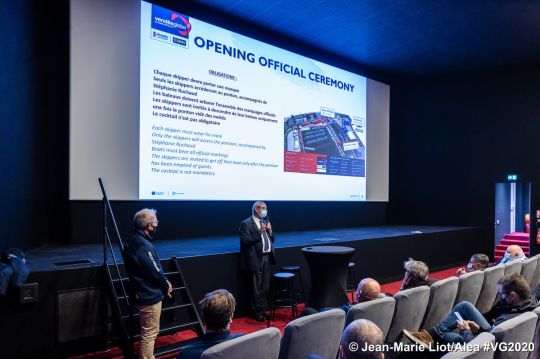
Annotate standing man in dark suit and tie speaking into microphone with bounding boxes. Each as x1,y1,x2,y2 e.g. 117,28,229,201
238,201,276,322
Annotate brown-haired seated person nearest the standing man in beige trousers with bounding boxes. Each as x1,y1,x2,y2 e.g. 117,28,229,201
177,289,242,359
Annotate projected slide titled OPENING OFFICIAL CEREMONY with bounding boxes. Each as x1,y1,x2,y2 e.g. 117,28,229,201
139,2,369,201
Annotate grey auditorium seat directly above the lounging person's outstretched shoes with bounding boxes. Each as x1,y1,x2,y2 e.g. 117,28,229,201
386,285,429,344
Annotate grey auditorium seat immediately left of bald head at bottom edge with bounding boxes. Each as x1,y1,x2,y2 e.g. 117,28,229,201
276,309,345,359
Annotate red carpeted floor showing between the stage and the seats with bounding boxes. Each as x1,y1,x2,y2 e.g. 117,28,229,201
71,268,458,359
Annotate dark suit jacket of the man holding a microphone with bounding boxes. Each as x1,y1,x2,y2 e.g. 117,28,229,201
238,216,276,271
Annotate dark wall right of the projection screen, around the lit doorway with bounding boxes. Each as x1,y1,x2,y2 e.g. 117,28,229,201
388,68,540,255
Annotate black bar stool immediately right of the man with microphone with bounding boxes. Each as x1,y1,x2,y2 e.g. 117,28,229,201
268,272,298,327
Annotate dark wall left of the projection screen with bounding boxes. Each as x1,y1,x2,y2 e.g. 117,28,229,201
0,0,69,249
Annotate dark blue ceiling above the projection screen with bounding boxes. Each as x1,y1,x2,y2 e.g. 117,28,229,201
198,0,540,75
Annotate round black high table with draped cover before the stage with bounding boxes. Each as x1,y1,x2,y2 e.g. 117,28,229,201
302,246,355,310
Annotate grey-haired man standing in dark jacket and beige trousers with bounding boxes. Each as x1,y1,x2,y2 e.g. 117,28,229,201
123,208,172,359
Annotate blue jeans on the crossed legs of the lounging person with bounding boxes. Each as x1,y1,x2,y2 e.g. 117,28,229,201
433,302,491,344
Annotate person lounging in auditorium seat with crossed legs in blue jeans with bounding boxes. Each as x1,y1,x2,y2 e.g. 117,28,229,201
403,273,539,347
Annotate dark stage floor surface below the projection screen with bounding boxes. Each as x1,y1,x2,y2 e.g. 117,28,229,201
27,225,467,272
